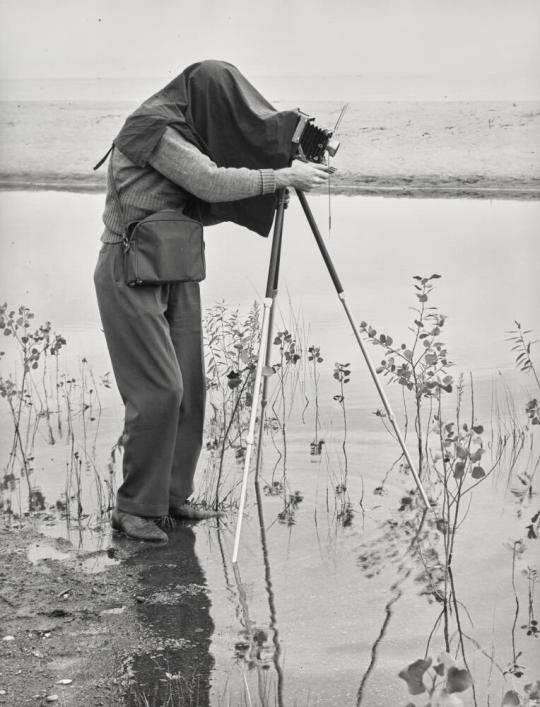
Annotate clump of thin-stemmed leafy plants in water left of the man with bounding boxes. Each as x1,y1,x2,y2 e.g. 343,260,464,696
0,304,115,522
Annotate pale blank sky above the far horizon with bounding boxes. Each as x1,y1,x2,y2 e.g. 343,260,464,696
0,0,540,79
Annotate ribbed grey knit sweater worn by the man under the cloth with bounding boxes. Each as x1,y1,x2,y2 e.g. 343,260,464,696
101,128,276,243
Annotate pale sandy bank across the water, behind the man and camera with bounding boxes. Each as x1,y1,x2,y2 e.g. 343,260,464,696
0,101,540,199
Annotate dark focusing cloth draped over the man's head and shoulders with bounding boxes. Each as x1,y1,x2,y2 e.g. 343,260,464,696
114,60,298,236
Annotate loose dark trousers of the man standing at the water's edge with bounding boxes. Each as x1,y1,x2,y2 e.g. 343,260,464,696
94,243,206,517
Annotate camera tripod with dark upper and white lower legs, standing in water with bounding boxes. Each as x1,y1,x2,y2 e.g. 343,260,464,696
232,189,431,563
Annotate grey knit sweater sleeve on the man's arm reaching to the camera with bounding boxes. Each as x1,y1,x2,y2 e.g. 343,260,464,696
150,127,276,203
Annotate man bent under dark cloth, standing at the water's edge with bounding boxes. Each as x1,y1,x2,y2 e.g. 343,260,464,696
94,61,328,541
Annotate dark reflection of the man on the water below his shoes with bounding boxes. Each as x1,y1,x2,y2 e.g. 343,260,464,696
126,527,214,707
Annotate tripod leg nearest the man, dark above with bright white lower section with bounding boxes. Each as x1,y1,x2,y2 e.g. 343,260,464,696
232,189,285,562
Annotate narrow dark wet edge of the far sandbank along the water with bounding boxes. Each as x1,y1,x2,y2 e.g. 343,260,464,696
0,172,540,201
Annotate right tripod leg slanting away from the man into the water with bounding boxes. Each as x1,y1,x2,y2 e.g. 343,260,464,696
296,191,431,508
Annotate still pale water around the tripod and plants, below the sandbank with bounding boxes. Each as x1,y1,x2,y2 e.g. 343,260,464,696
0,193,540,707
